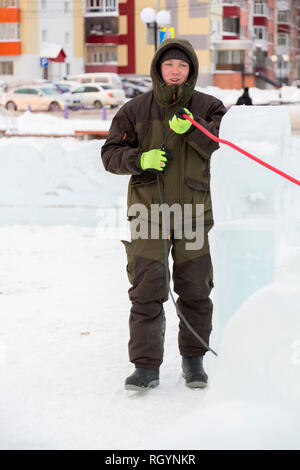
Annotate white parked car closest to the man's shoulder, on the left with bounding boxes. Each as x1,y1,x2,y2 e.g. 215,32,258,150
72,83,125,109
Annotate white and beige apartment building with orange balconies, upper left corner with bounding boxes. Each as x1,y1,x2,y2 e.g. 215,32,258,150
0,0,84,83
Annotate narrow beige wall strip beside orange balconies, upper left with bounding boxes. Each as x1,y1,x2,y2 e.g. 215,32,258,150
20,0,39,54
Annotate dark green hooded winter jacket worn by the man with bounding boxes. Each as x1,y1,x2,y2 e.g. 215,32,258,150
102,39,226,224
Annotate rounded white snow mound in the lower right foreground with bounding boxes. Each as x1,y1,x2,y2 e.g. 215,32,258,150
153,252,300,450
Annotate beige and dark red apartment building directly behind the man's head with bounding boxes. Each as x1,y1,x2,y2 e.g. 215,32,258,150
84,0,211,85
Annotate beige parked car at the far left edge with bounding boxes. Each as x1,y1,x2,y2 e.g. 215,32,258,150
0,85,81,111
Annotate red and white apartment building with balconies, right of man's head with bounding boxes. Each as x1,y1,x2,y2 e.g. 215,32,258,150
211,0,276,88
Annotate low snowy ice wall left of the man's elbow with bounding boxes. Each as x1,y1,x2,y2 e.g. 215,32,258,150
0,139,128,207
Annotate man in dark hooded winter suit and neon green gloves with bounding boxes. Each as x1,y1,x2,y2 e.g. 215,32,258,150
102,39,226,390
